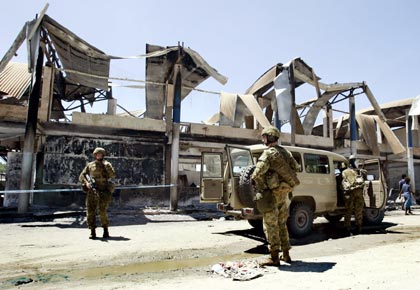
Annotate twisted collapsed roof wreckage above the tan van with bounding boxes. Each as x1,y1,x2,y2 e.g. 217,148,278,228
207,58,405,155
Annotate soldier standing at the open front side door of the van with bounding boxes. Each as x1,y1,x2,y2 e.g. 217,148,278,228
342,155,366,233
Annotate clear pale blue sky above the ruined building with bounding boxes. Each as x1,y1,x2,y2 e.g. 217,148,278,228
0,0,420,122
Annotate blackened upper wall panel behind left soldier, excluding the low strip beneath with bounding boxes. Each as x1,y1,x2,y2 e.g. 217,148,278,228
42,136,164,185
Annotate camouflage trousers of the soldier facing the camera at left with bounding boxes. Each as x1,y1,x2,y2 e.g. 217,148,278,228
86,191,111,229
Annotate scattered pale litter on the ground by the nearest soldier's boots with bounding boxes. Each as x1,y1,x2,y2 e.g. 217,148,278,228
211,261,263,281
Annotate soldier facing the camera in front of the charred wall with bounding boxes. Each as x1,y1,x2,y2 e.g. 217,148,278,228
79,147,115,239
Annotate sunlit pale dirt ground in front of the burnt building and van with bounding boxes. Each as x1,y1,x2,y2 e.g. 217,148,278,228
0,209,420,290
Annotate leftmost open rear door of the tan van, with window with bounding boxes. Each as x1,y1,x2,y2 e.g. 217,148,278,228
200,152,223,203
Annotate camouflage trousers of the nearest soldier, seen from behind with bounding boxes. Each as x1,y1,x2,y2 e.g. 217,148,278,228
263,189,291,252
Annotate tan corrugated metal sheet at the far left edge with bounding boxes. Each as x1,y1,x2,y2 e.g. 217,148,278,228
0,62,31,99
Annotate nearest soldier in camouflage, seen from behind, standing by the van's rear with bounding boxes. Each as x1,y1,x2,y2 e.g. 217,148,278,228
251,127,299,266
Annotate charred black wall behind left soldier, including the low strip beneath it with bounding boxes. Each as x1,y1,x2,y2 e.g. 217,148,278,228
32,136,169,206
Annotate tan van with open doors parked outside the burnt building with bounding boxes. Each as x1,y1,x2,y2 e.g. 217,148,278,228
200,144,386,237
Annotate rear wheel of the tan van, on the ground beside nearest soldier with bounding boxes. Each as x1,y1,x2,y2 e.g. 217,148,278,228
287,202,314,237
